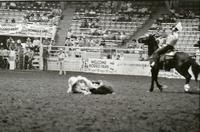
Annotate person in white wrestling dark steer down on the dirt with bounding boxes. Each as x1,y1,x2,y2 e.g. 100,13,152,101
67,76,113,95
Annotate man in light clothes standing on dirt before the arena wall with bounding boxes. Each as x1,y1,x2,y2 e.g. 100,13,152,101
58,48,66,75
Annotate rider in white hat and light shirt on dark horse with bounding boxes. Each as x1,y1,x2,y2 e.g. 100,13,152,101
150,22,182,67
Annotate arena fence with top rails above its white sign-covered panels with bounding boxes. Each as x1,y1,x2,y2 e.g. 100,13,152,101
35,46,200,78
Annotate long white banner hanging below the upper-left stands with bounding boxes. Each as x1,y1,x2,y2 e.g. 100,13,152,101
0,23,56,38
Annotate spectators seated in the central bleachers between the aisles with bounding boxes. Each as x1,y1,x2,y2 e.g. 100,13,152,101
68,1,153,47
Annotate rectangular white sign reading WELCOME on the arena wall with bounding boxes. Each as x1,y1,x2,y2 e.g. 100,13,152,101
81,58,115,74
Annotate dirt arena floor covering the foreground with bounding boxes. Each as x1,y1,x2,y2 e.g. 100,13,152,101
0,70,200,132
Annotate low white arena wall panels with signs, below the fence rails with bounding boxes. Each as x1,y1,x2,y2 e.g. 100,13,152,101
48,58,198,79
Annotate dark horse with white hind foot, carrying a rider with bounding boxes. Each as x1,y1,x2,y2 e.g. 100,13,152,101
138,35,200,92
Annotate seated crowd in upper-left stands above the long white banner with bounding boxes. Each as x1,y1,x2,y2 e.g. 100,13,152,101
0,2,63,25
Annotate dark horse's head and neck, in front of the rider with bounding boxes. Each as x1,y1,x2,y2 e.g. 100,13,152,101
138,34,158,56
